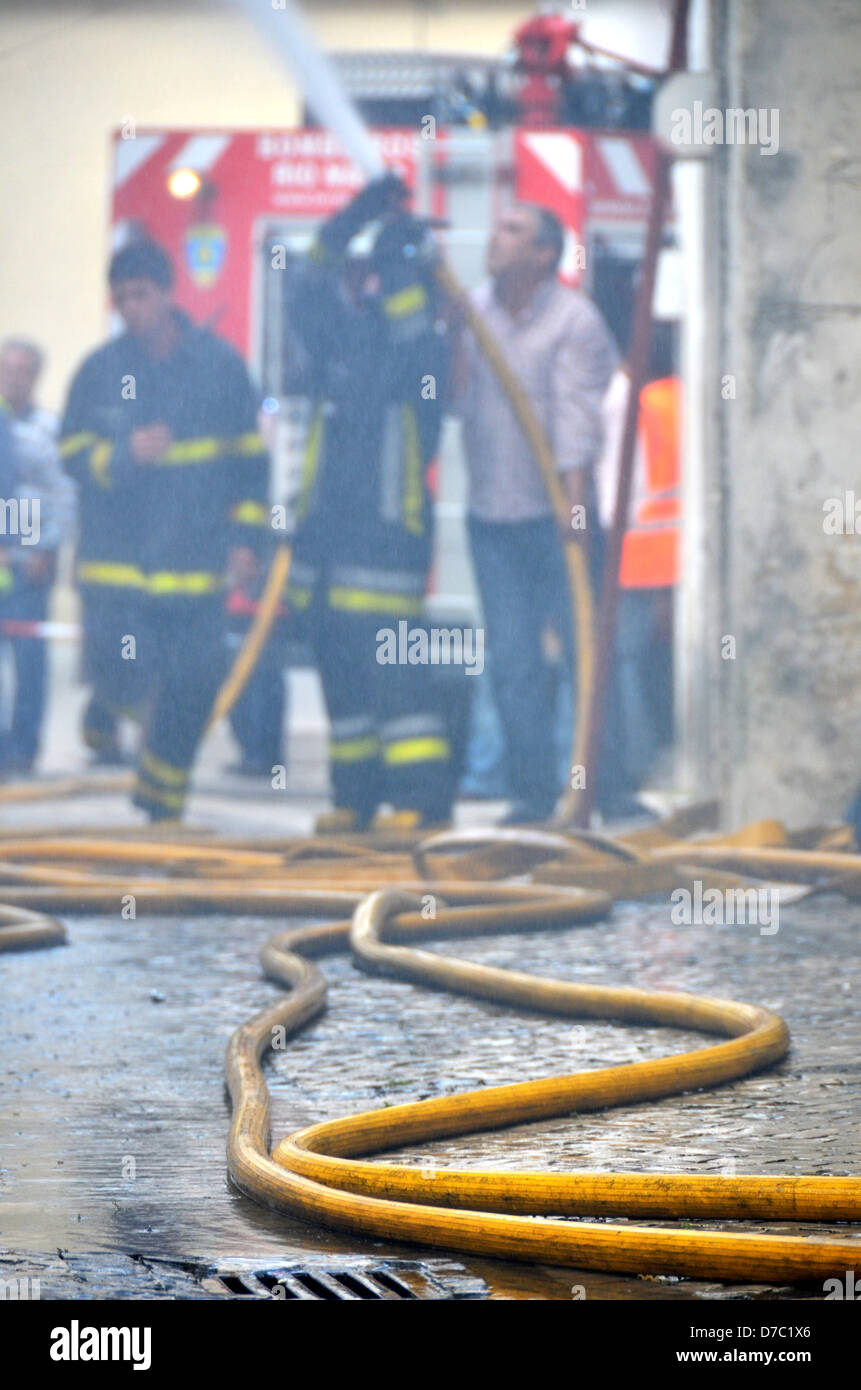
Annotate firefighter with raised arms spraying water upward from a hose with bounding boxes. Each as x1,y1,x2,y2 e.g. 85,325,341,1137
288,175,453,831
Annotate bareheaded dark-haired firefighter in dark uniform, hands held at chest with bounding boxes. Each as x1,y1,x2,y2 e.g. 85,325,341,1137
61,242,270,820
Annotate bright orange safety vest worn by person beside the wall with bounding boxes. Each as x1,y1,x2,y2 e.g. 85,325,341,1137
619,377,682,589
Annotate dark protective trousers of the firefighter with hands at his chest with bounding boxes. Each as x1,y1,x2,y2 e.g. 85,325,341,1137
85,591,227,819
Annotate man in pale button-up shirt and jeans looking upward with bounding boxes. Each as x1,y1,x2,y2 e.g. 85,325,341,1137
458,203,618,823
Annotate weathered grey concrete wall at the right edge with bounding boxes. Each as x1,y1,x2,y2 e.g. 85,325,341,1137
704,0,861,824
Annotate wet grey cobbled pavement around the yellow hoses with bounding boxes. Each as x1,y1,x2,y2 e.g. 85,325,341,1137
0,834,861,1298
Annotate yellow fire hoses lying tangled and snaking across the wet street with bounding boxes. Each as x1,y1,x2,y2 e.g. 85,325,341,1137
0,821,861,1282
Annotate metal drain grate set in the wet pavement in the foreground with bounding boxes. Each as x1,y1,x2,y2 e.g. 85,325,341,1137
200,1261,488,1302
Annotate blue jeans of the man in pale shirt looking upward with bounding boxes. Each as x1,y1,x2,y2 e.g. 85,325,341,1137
469,517,573,816
